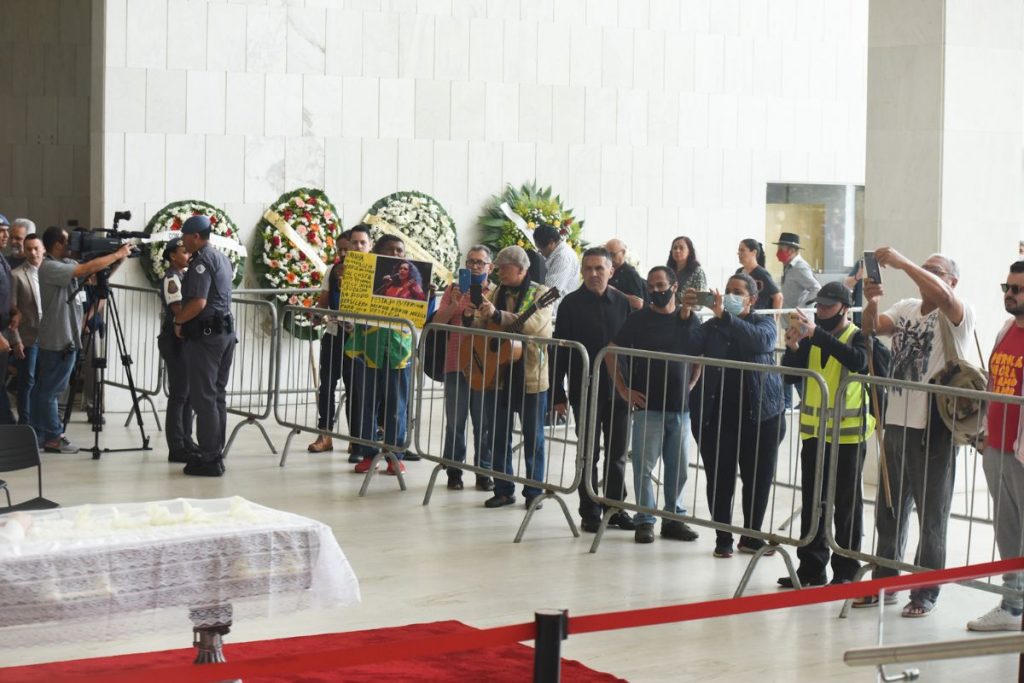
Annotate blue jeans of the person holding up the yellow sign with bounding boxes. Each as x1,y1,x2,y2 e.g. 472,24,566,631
349,362,413,460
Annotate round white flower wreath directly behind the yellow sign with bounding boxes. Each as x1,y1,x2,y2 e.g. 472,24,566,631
362,191,459,289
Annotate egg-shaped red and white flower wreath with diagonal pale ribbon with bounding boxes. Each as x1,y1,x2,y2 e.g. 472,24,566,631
254,187,343,339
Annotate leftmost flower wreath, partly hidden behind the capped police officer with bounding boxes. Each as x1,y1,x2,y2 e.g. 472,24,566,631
142,200,245,287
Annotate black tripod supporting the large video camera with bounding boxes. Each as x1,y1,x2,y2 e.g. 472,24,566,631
63,268,153,460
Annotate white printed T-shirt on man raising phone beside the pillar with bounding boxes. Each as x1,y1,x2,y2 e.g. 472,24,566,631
883,299,975,429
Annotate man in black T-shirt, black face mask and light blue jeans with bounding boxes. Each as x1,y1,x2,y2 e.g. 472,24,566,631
605,265,697,543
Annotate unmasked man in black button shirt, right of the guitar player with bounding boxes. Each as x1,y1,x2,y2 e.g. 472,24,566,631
554,247,633,532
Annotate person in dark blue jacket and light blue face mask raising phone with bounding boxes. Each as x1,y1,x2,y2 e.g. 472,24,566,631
684,272,785,557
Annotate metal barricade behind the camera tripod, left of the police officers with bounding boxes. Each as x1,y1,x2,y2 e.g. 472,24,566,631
107,285,164,429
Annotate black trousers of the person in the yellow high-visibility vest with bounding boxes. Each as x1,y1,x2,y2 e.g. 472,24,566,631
797,438,864,581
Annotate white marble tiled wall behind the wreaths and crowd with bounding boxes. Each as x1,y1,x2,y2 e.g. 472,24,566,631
93,0,867,281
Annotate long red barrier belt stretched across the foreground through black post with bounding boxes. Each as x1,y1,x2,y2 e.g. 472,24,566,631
12,557,1024,683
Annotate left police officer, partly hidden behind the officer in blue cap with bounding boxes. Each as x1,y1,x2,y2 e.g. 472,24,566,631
157,238,199,463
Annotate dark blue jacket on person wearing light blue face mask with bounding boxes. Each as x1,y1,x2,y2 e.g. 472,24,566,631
690,312,782,424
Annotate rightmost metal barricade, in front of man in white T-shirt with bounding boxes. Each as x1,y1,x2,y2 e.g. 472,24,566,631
825,375,1024,616
